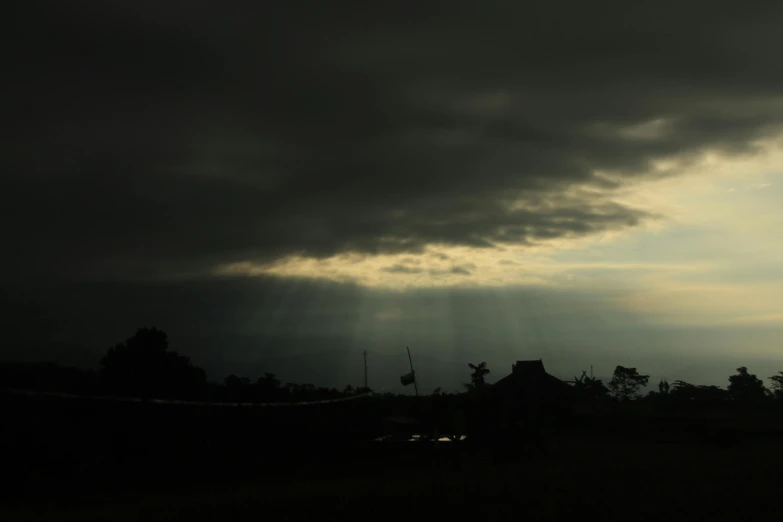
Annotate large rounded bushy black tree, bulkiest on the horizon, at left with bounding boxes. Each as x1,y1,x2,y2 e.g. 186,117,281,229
101,328,207,398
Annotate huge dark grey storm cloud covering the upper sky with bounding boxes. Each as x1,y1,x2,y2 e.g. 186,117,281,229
6,1,783,278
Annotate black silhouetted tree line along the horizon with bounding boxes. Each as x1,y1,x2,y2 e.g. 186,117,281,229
0,328,783,404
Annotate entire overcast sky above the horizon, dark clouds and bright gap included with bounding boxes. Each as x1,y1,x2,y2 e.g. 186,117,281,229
0,0,783,388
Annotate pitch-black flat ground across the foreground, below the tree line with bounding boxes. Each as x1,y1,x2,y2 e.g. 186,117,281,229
0,392,783,522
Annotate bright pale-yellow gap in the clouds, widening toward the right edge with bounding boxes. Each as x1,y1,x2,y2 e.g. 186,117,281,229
216,137,783,334
